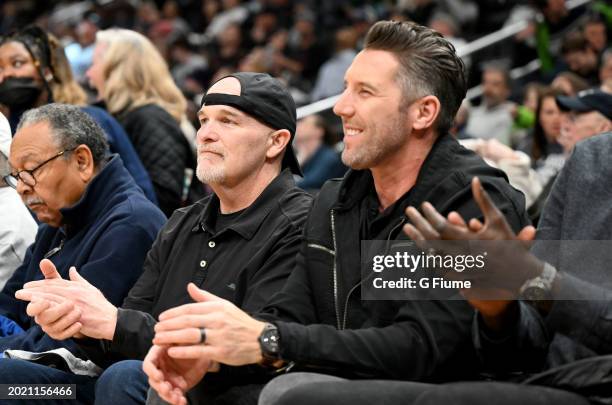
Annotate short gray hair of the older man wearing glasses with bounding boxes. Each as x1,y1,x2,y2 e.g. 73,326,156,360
17,103,108,167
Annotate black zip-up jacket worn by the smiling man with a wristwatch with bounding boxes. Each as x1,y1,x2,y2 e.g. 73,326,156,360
260,135,529,381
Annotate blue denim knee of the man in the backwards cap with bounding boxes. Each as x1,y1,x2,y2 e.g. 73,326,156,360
96,360,149,405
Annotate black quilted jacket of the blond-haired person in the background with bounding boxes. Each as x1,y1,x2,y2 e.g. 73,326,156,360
117,104,195,217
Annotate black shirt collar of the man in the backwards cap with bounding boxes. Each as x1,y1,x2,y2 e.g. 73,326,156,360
198,169,295,240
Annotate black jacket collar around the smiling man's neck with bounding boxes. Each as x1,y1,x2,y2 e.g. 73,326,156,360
334,134,459,211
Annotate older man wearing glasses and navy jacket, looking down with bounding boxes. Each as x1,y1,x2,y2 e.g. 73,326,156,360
0,104,165,400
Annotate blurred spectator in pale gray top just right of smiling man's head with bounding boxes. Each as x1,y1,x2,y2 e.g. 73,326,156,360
465,65,514,145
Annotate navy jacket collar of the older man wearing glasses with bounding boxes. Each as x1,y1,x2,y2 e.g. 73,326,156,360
60,155,133,237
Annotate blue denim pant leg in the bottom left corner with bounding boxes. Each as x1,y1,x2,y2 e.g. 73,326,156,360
0,358,96,405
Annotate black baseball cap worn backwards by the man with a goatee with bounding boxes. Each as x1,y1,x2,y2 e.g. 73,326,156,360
201,72,302,176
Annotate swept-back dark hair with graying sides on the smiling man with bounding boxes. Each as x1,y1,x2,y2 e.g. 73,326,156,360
365,21,467,134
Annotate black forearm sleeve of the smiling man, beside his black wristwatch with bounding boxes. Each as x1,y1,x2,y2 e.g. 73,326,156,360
276,300,473,380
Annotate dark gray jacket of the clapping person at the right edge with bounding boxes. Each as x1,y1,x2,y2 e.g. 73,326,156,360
475,133,612,373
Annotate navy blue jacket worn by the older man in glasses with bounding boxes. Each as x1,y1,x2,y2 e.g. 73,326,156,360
0,155,166,352
